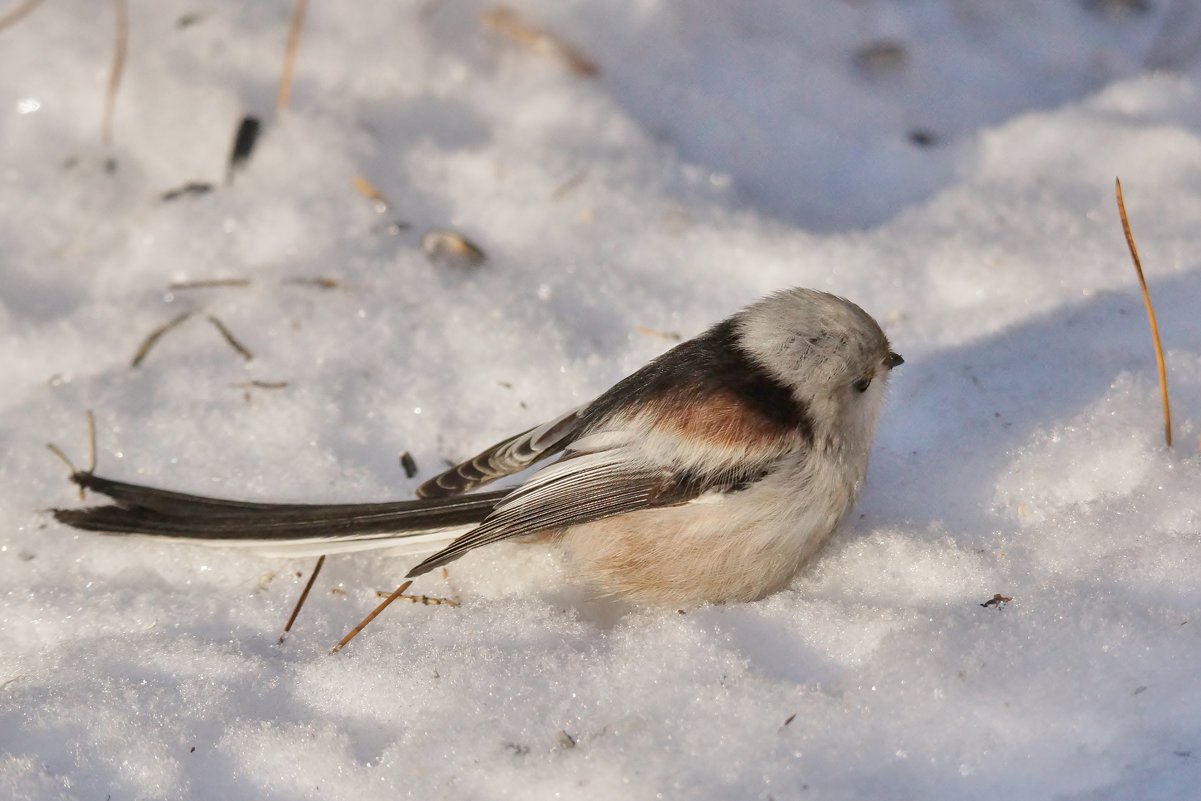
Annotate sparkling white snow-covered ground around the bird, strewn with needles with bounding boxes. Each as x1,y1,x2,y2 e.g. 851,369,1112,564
0,0,1201,801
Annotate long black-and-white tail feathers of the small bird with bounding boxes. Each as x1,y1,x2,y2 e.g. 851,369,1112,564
53,472,508,542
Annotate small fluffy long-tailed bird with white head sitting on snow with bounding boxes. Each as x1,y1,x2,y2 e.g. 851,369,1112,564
54,288,903,606
